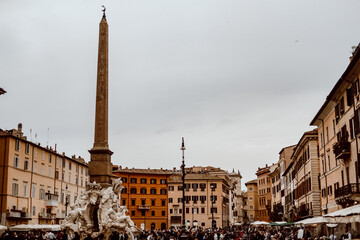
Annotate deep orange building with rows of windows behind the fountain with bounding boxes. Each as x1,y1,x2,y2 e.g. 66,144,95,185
113,166,172,230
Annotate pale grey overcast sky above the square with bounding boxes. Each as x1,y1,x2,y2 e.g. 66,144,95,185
0,0,360,188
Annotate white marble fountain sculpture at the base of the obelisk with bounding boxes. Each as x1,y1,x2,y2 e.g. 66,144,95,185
61,179,140,240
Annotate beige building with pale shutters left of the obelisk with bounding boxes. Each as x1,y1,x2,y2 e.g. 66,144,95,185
0,124,88,226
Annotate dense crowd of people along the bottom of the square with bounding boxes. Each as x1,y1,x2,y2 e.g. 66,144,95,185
0,227,351,240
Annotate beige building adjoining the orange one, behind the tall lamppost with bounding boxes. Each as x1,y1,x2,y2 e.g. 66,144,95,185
168,167,231,228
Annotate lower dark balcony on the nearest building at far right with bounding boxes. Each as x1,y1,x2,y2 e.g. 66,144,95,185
335,183,360,206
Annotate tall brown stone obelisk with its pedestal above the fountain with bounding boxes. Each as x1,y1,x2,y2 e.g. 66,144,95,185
88,7,113,185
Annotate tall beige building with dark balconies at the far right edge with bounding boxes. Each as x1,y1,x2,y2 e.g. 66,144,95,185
310,47,360,214
